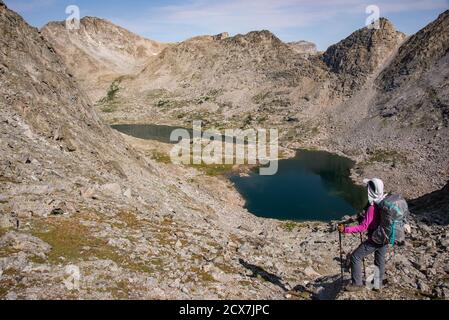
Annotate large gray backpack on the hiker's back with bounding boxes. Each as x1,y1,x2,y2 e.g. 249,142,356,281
371,194,409,246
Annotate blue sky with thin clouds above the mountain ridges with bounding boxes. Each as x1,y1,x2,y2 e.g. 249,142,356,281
5,0,449,50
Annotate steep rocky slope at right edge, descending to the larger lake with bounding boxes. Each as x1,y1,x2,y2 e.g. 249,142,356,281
322,11,449,197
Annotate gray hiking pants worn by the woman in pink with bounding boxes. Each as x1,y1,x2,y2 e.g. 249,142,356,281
351,241,388,286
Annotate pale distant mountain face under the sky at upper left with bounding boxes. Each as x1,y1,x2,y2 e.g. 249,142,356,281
41,17,167,101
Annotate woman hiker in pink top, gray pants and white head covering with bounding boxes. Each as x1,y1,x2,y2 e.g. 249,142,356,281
338,179,388,291
